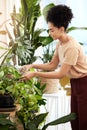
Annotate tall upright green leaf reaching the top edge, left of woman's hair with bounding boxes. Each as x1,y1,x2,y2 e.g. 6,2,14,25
21,0,40,34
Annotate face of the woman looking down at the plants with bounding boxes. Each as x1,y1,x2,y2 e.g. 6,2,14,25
48,22,62,40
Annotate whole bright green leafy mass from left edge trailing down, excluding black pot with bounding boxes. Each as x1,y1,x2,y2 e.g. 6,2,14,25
0,65,46,129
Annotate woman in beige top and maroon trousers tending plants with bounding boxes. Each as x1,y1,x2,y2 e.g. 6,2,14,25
21,5,87,130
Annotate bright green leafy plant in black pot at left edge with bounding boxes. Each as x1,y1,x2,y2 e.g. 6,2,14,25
0,65,20,108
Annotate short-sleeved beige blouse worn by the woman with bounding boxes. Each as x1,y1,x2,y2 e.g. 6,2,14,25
58,38,87,78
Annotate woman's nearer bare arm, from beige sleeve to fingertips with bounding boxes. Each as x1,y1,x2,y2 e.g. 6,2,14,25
21,64,71,80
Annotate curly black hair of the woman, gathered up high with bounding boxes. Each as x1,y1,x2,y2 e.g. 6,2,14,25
46,5,73,30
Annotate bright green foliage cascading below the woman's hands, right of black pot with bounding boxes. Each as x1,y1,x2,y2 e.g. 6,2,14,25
17,81,46,130
